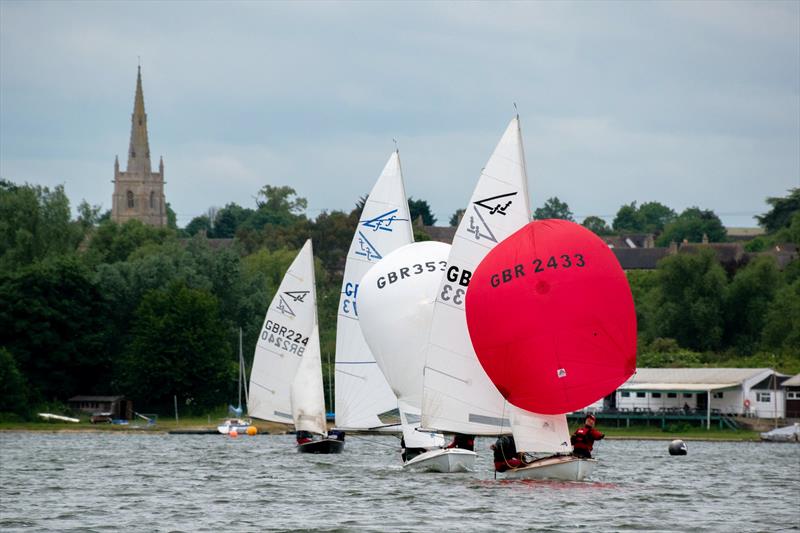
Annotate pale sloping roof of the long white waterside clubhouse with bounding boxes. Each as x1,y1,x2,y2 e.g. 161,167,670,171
620,368,772,391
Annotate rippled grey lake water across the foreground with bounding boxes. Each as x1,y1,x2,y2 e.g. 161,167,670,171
0,432,800,532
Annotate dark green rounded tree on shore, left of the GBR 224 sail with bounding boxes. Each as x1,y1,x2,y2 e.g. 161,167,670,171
121,283,236,411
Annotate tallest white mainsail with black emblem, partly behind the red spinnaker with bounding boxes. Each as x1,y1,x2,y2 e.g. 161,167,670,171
422,118,569,451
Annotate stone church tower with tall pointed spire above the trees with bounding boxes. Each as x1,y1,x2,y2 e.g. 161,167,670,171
111,67,167,226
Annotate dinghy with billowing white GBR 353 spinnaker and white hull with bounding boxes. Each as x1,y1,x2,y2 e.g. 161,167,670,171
358,241,476,472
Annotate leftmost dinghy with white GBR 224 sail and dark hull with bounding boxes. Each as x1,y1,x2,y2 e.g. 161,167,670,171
248,239,344,453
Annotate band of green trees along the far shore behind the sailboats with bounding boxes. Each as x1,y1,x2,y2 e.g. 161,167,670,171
0,181,800,417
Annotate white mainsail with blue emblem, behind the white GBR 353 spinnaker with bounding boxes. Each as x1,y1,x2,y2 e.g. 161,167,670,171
336,152,414,429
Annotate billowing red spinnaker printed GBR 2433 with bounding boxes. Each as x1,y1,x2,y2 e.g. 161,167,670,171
466,220,636,414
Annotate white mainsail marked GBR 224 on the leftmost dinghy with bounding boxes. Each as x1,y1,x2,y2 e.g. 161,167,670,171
248,240,317,424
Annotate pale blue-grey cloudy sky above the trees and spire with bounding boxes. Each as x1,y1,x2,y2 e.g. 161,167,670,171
0,0,800,227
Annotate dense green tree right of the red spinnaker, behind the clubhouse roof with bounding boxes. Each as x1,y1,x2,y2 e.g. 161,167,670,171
650,250,727,350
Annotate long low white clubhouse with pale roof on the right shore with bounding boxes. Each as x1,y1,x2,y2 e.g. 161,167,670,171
608,368,786,418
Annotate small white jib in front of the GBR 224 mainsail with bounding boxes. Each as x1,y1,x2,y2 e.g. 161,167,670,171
292,324,327,435
